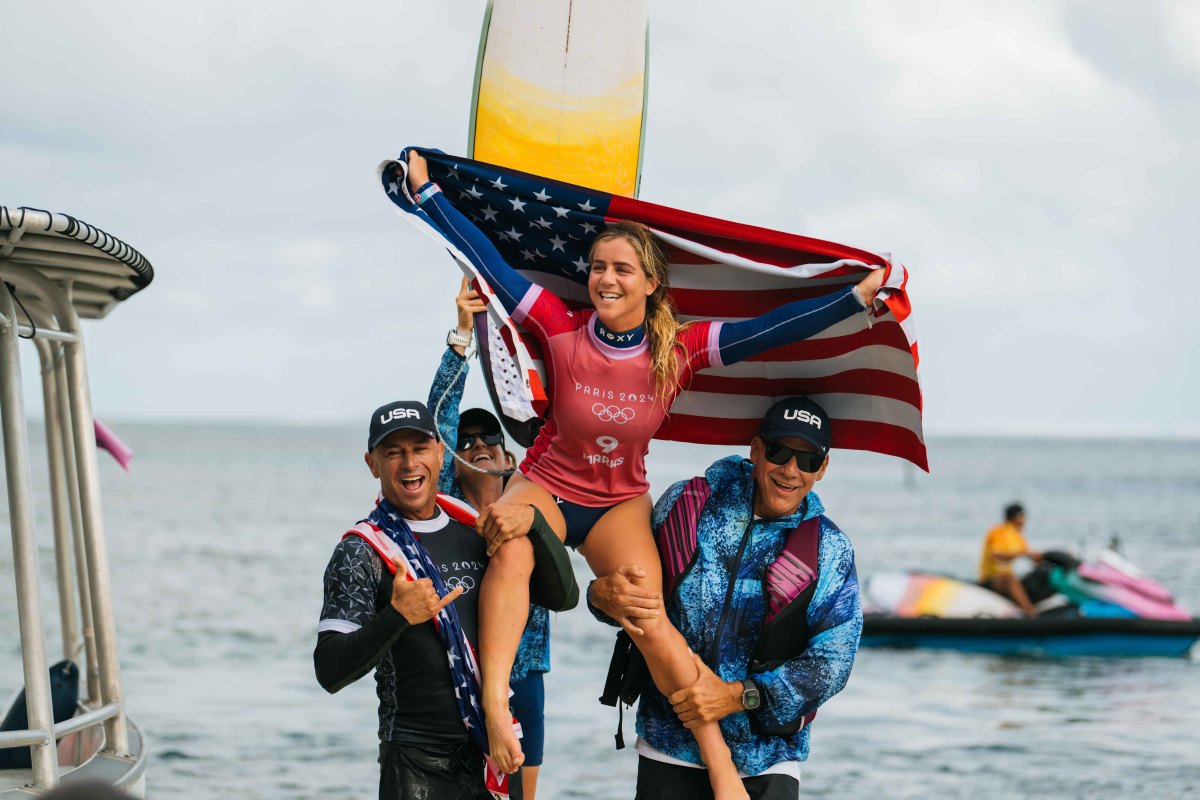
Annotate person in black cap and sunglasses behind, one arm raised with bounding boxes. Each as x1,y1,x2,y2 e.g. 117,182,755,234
428,278,550,800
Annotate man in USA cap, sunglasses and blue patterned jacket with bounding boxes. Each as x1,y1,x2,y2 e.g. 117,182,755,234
588,397,863,800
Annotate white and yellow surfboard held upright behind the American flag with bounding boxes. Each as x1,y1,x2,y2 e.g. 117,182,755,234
467,0,649,447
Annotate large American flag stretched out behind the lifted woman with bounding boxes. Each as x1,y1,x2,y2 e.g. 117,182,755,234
379,150,929,470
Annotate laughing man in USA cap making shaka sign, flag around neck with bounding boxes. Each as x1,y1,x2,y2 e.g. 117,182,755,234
313,401,578,800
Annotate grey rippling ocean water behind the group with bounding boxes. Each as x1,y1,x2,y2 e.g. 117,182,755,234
0,425,1200,800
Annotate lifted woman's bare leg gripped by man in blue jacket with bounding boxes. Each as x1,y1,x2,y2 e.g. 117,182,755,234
580,494,749,800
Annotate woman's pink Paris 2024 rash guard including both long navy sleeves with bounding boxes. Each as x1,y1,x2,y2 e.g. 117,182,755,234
421,184,864,507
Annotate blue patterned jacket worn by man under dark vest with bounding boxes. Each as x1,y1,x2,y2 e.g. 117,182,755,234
605,456,863,775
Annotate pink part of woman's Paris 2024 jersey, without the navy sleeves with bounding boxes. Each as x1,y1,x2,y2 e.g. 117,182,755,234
512,285,721,507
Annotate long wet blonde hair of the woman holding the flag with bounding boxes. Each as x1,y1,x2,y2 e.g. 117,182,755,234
588,221,691,402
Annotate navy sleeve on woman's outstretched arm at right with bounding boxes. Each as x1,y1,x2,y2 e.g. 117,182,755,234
718,287,863,365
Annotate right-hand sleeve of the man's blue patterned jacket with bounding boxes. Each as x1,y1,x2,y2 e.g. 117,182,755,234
751,524,863,727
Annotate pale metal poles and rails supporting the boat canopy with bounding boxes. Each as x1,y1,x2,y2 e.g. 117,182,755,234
0,209,149,793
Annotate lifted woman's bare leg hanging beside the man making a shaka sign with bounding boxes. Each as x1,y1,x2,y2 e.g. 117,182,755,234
479,474,566,780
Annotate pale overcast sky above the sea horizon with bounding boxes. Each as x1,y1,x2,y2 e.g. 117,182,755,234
0,0,1200,435
